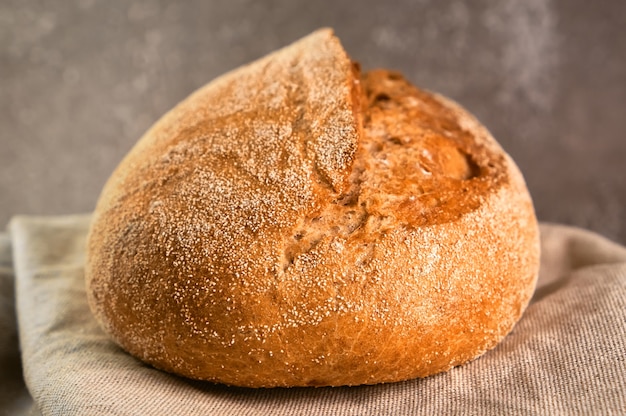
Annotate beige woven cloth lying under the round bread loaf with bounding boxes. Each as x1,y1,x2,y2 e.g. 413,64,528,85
4,216,626,416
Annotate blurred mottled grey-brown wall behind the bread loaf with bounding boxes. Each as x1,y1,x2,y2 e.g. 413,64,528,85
0,0,626,242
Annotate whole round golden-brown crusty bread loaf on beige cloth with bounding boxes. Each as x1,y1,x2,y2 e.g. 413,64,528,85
86,29,539,387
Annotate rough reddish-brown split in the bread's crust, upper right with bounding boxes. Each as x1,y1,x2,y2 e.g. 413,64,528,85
283,65,505,270
